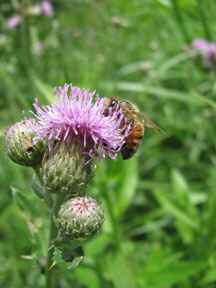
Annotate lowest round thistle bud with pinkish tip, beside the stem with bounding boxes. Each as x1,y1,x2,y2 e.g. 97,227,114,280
56,197,104,240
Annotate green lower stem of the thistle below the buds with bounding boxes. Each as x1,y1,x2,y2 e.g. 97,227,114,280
46,210,57,288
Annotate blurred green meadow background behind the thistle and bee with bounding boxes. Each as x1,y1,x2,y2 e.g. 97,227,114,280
0,0,216,288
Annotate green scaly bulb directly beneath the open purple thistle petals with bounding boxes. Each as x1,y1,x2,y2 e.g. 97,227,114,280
40,143,92,196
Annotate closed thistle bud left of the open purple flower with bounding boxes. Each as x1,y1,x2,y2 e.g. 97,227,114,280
5,119,43,166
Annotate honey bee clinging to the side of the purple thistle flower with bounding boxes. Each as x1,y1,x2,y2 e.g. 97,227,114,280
104,97,161,160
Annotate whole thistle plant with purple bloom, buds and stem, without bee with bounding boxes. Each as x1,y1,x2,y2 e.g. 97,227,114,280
5,84,130,288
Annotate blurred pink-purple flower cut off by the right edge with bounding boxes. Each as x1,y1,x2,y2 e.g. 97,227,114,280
191,39,216,66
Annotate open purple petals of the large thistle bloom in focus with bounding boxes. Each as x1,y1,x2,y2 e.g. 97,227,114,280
34,84,130,158
